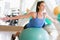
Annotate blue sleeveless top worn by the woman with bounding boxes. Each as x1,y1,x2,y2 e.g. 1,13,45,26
26,13,45,28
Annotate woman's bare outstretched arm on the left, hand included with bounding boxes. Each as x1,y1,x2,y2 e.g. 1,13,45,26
0,12,33,20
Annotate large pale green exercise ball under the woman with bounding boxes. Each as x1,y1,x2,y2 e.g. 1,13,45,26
19,28,49,40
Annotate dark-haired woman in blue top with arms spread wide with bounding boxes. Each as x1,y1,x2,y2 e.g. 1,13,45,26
1,1,57,40
